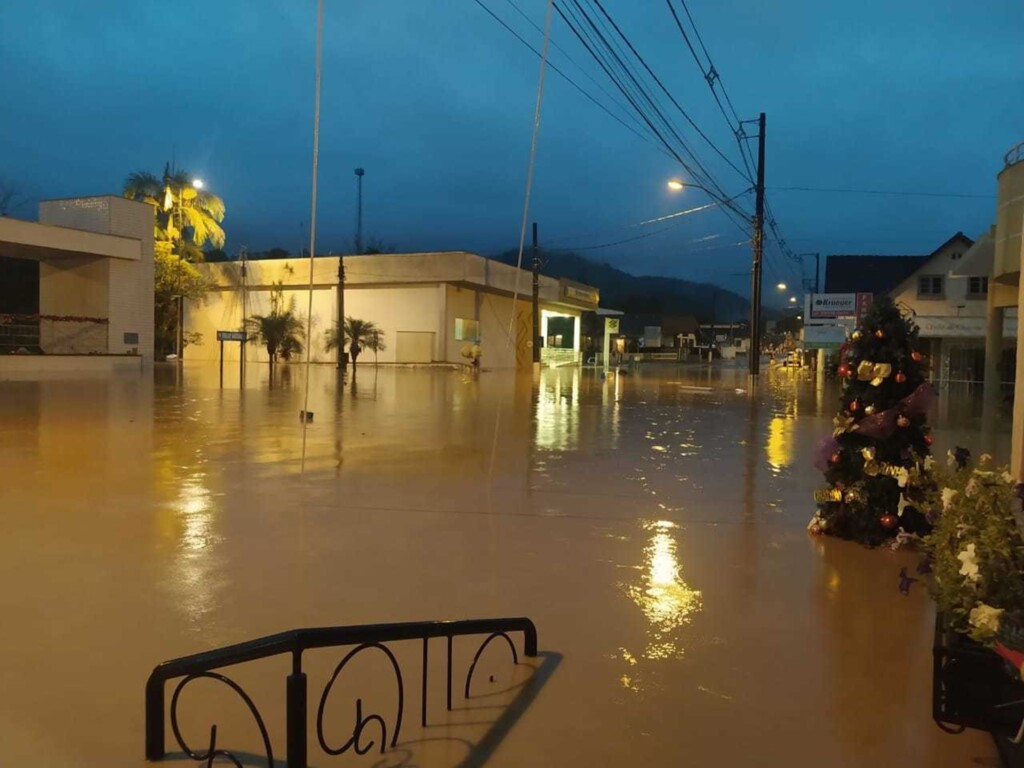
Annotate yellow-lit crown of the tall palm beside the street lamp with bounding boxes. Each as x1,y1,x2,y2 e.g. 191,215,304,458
123,165,224,261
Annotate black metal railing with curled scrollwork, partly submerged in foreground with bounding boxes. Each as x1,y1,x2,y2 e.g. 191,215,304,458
145,617,538,768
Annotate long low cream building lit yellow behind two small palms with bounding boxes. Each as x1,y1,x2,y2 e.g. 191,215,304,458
190,251,599,369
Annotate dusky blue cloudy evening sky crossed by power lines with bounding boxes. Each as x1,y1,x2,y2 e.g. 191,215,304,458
0,0,1024,301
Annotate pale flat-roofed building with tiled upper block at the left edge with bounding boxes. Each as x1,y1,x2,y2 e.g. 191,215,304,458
0,195,154,372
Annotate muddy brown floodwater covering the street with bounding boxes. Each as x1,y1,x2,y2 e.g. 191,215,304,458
0,364,1009,768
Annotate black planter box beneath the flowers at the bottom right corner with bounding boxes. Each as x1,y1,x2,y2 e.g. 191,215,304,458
932,614,1024,766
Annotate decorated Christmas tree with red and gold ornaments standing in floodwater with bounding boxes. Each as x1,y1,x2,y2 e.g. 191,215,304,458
808,298,935,546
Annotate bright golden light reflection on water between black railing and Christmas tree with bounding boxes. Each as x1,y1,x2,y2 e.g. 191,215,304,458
621,520,701,690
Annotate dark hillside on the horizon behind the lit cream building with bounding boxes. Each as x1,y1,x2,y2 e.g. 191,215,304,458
498,251,751,323
